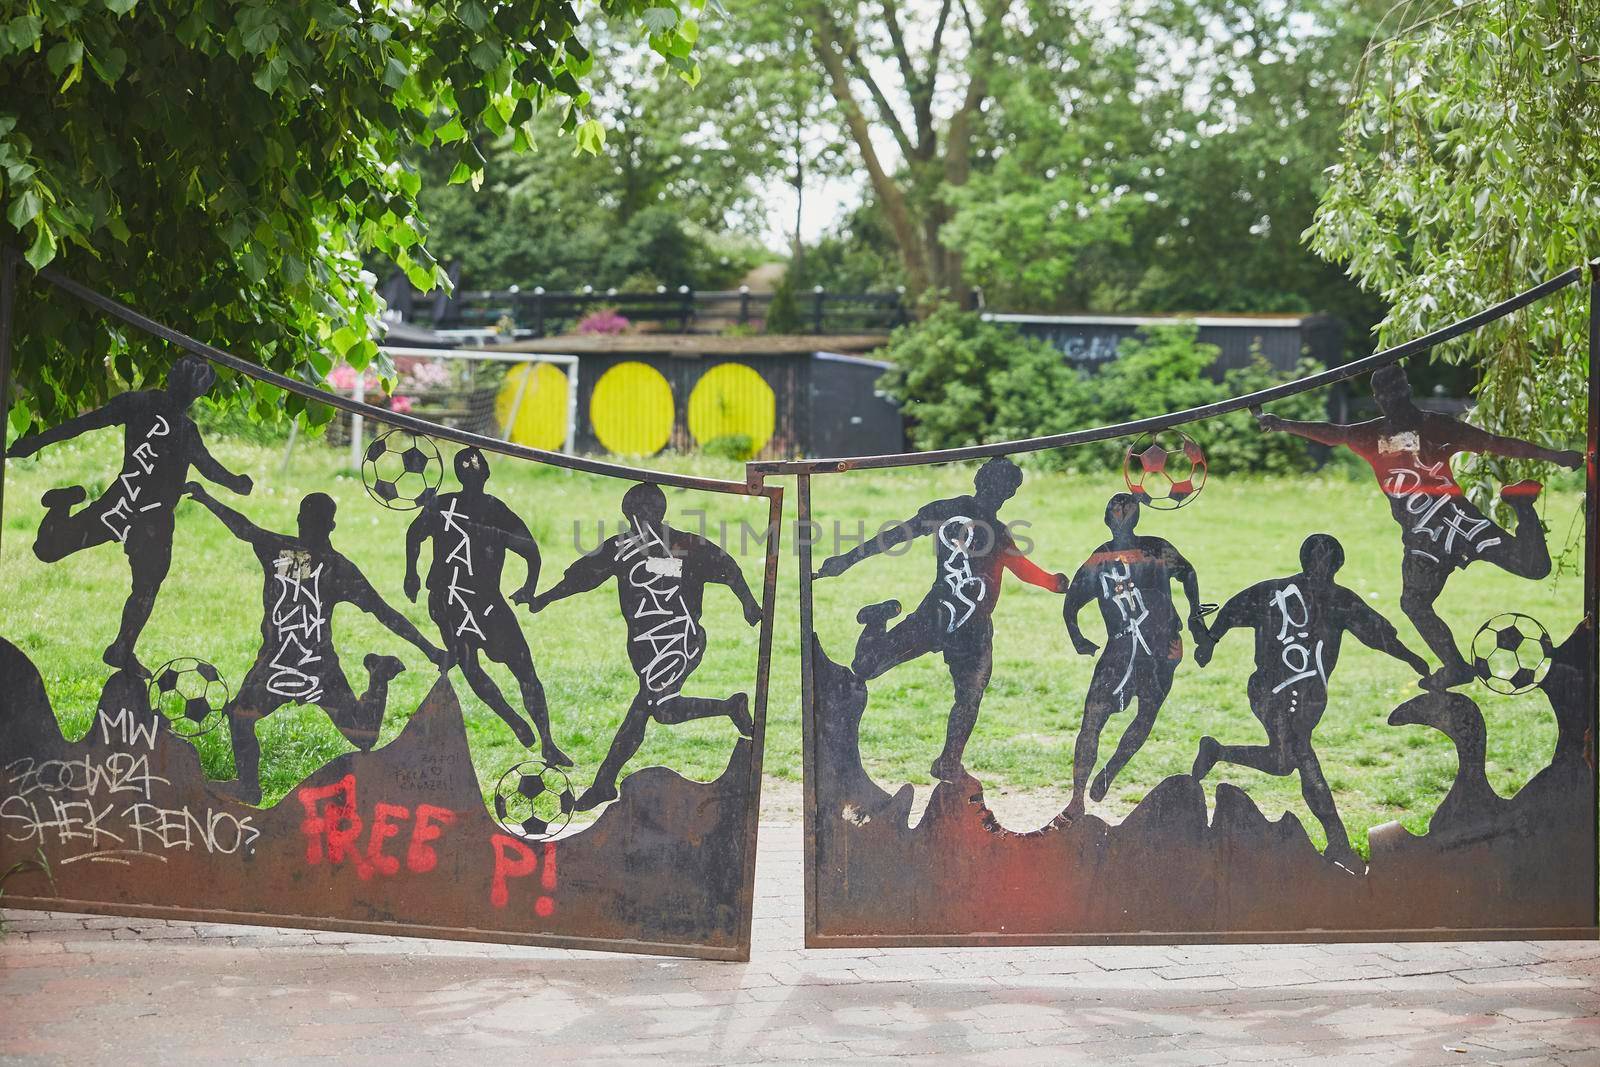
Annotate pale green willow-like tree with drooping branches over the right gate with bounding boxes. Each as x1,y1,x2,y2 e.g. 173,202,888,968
1309,0,1600,454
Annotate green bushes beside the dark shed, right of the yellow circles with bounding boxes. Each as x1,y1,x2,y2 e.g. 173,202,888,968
886,307,1325,474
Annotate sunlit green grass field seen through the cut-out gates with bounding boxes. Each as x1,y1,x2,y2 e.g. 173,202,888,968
0,432,1582,848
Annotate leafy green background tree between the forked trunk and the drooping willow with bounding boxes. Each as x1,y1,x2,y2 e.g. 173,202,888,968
944,0,1381,336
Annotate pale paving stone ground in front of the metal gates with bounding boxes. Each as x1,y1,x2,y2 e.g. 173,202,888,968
0,825,1600,1067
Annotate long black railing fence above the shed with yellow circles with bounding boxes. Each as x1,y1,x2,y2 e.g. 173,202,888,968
384,278,912,338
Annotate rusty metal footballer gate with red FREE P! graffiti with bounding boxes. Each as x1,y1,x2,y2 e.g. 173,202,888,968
0,254,782,960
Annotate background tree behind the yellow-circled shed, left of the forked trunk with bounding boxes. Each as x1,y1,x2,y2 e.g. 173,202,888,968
412,24,787,290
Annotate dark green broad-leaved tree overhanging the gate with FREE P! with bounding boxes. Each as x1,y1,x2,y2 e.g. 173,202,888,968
0,0,702,429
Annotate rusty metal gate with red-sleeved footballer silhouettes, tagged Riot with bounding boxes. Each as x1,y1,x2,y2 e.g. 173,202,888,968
754,262,1600,947
